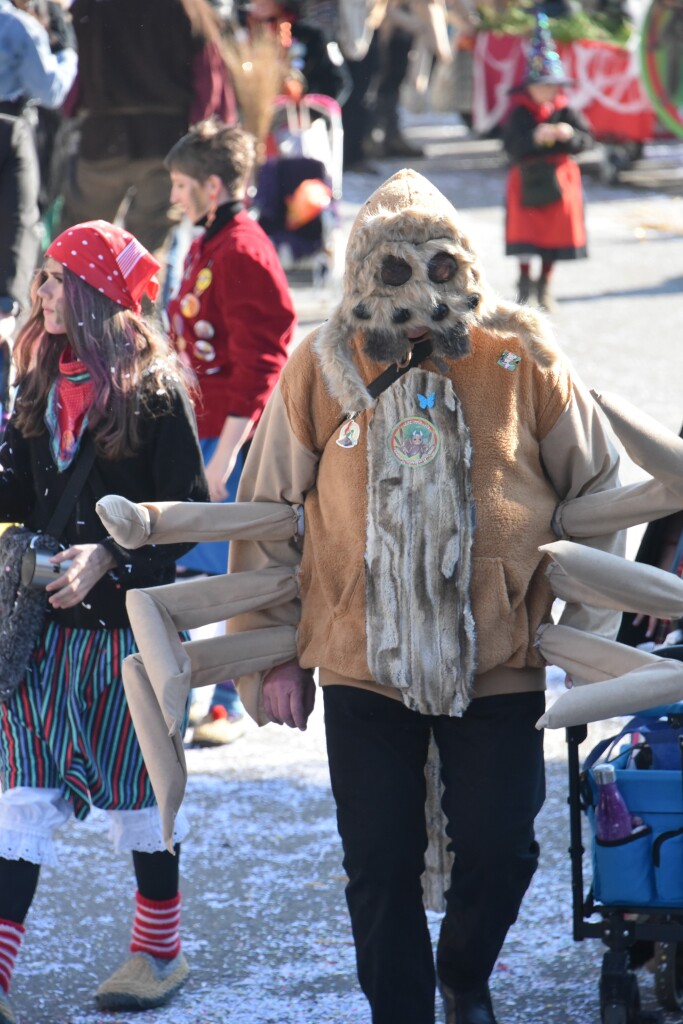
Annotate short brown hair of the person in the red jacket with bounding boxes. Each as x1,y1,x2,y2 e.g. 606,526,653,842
164,118,256,196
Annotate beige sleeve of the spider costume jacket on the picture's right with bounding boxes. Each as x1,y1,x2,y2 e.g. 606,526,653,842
541,372,626,639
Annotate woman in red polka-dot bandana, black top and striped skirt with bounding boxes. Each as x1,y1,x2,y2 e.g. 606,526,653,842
0,220,208,1024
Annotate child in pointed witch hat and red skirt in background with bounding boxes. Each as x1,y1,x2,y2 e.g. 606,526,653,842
503,13,592,311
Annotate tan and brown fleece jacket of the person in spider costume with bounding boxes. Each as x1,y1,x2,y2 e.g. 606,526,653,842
227,328,623,720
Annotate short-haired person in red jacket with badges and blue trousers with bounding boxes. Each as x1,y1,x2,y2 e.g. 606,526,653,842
166,120,296,745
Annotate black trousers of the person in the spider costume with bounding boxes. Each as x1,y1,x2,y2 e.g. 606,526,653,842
324,686,545,1024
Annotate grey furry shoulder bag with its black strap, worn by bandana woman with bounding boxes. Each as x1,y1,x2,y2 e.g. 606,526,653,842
0,434,95,702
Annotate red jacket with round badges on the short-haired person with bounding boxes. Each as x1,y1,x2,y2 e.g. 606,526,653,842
168,208,296,438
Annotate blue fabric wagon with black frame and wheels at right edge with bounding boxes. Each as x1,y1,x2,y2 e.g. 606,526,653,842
566,646,683,1024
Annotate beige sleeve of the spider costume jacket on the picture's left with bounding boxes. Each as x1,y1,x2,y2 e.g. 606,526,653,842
226,387,318,725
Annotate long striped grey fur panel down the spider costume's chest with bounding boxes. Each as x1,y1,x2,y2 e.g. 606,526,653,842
366,370,475,716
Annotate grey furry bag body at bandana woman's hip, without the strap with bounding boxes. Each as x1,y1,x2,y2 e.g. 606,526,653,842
0,526,59,701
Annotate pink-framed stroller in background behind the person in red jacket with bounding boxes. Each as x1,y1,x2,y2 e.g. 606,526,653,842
254,93,343,287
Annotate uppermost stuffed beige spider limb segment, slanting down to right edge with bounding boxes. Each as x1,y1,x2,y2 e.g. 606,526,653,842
591,391,683,501
